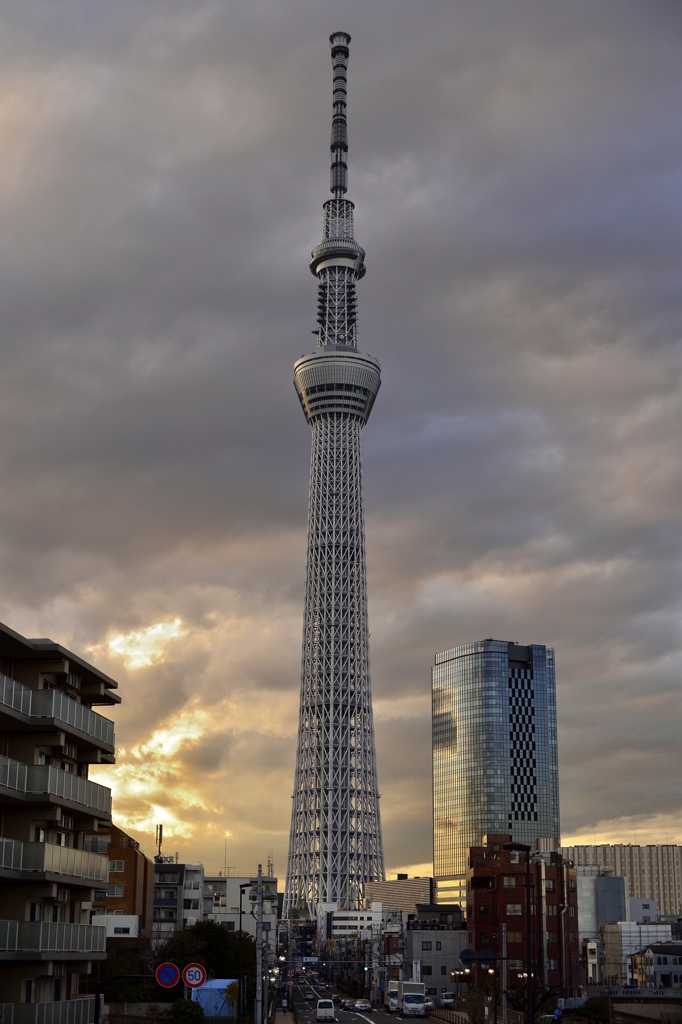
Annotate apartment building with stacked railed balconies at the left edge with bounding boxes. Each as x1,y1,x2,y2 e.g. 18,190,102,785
0,624,120,1024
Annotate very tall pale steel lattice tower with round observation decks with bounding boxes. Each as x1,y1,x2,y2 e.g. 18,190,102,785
285,32,384,918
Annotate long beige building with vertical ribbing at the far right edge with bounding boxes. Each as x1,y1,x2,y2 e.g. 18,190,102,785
561,843,682,915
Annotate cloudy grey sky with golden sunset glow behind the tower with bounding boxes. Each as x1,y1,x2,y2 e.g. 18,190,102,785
0,0,682,878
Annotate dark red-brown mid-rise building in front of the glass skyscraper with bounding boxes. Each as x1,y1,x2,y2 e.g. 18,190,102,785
467,834,583,995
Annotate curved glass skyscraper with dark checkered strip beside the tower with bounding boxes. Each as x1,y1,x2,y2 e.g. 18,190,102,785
432,640,560,902
